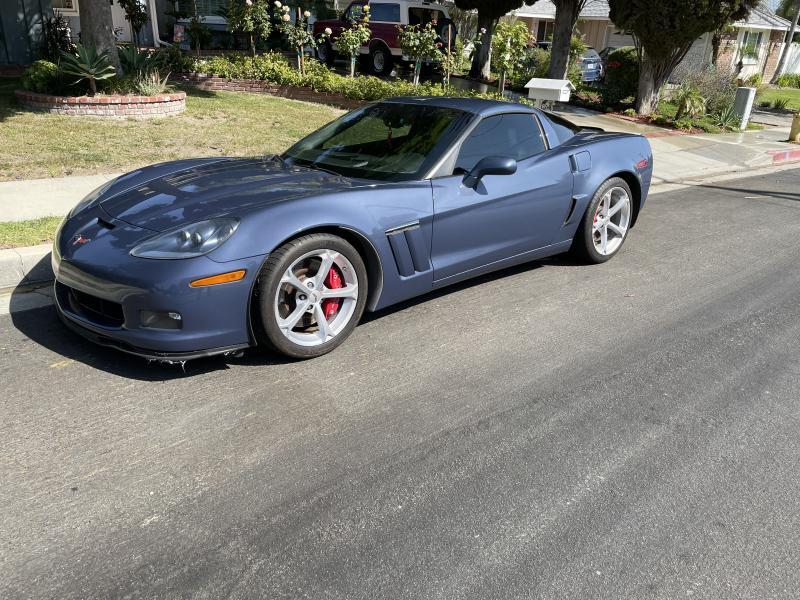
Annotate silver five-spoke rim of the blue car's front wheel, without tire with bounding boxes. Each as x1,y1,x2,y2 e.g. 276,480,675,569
274,249,358,346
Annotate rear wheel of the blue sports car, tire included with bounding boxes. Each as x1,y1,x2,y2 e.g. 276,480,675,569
572,177,633,263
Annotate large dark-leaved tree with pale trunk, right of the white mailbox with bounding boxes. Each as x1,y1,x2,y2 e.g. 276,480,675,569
609,0,760,115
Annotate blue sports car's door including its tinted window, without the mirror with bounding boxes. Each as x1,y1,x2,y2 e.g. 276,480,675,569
431,113,573,281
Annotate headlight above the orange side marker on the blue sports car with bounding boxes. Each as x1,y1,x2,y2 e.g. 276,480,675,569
131,218,239,259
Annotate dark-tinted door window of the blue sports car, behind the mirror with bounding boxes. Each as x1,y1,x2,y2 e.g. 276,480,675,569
455,113,547,172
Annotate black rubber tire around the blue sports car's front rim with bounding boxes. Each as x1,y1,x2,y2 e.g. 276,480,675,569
253,233,369,359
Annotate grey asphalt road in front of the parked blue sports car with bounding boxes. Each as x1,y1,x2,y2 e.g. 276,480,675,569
0,170,800,600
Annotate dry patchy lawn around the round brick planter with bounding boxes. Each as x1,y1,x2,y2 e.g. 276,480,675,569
0,79,344,181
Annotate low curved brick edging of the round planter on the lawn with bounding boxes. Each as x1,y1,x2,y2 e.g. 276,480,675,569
14,90,186,117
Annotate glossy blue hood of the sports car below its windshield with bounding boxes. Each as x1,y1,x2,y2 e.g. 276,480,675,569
100,158,356,231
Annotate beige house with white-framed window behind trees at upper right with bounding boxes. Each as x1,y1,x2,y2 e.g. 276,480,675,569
512,0,800,80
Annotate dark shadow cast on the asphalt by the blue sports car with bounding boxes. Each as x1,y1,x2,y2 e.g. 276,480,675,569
10,255,581,381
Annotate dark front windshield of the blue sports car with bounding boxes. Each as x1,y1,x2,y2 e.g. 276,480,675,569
283,102,471,181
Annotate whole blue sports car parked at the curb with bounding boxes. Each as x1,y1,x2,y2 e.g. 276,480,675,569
52,98,653,362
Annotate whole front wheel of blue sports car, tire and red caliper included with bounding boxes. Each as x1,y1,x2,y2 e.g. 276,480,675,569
256,234,367,358
